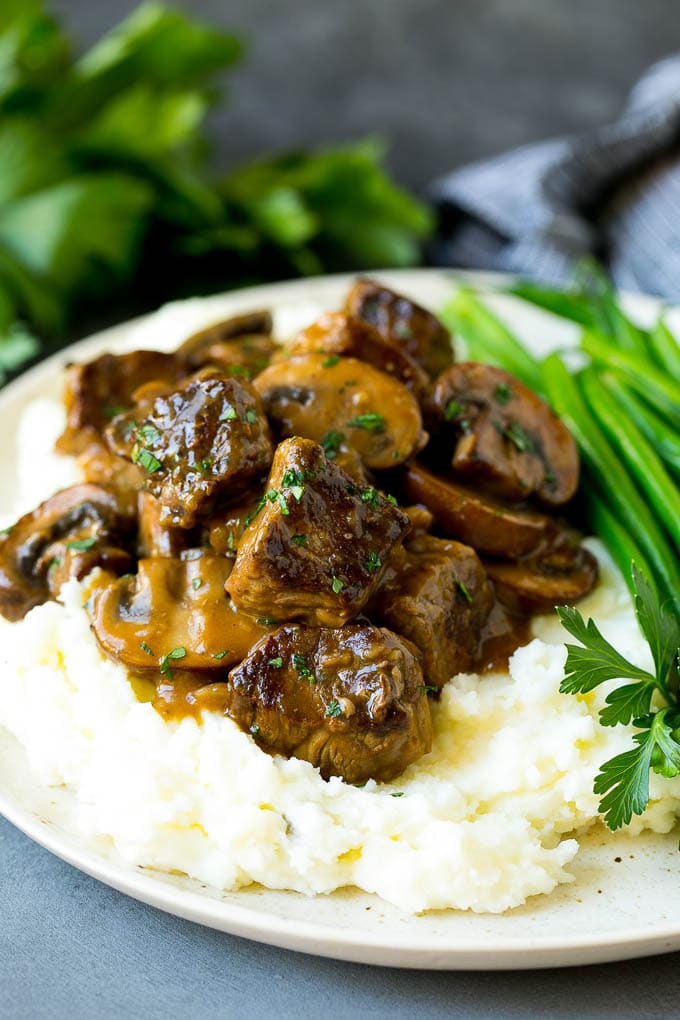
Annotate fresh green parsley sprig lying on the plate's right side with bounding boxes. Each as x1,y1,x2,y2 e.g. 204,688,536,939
558,564,680,830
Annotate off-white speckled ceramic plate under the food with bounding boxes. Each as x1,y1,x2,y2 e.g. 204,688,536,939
0,270,680,970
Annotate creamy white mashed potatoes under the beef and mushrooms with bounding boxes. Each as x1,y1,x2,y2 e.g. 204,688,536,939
0,402,680,912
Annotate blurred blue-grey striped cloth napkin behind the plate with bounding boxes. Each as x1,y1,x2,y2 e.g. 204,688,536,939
430,56,680,301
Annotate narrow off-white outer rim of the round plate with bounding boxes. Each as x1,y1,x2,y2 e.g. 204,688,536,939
5,268,680,970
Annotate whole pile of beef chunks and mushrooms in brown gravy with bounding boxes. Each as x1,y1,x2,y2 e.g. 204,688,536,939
0,281,597,783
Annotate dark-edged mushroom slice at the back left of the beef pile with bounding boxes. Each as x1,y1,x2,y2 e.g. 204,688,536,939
177,312,278,378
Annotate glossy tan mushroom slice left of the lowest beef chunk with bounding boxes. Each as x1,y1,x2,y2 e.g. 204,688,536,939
89,550,267,682
